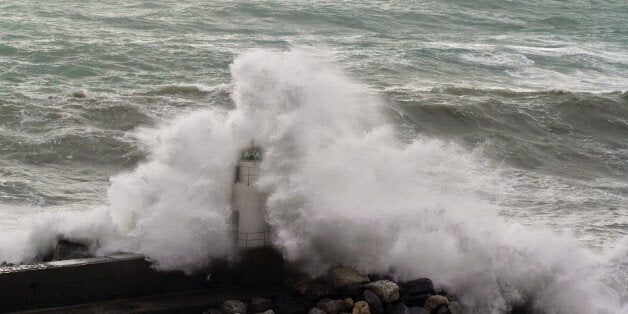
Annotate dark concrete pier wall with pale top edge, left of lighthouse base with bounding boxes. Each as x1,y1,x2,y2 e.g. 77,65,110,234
0,254,208,312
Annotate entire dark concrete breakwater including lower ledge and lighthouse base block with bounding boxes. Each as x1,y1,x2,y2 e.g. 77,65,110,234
0,247,283,313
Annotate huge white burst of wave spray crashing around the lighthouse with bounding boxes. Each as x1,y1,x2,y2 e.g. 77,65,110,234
0,51,628,313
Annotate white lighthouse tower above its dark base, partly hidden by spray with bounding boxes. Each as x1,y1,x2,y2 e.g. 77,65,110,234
233,146,270,250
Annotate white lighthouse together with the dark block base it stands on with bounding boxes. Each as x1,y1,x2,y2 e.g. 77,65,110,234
232,146,283,288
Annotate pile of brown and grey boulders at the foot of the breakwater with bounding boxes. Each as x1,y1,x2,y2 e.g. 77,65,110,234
204,268,461,314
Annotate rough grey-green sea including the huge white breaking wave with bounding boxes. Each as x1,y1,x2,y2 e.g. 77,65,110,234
0,0,628,313
